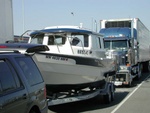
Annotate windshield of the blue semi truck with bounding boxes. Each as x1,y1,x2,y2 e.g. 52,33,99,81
104,40,128,49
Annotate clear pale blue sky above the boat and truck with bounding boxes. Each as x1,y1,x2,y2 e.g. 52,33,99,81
12,0,150,35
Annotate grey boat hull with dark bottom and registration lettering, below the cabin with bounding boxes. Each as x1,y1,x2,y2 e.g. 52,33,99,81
34,53,113,92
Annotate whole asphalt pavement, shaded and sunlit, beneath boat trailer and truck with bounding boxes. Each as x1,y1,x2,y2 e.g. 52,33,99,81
48,73,150,113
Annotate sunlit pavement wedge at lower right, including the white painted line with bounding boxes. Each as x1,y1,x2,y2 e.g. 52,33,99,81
111,74,150,113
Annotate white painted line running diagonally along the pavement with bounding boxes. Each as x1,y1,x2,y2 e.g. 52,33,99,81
111,75,150,113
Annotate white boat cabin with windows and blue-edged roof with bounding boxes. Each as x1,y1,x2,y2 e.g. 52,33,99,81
29,26,105,58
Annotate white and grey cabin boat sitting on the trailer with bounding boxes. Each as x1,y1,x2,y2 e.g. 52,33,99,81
29,26,114,92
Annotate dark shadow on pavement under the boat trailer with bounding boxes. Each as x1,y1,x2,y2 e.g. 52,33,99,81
49,92,129,113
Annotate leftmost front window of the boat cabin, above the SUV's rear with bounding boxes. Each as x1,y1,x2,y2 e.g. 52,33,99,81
31,34,44,44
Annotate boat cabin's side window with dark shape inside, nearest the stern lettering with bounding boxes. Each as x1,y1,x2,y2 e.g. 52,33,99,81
71,34,89,47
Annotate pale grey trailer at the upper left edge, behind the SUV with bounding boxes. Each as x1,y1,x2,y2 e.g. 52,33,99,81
0,0,13,43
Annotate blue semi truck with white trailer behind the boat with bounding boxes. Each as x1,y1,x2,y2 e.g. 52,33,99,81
99,18,150,86
